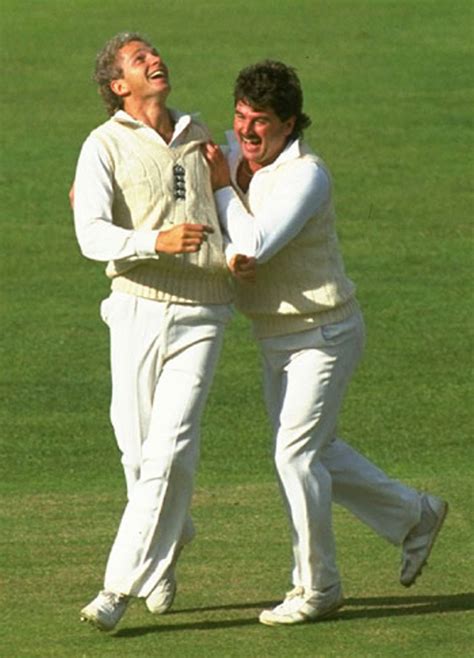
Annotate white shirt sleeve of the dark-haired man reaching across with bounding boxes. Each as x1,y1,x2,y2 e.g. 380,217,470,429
215,161,330,263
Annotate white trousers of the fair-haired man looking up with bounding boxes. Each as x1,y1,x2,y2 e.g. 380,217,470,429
101,292,232,597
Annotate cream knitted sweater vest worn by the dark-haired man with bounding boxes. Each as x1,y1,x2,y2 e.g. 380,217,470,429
231,149,359,338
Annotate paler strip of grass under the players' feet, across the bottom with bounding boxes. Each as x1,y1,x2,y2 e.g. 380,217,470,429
2,478,472,658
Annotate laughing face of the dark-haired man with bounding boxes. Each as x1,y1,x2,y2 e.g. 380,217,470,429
234,101,295,167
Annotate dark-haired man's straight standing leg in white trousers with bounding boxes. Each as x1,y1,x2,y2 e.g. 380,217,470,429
262,316,363,592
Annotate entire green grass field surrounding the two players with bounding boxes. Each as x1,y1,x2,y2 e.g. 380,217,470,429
0,0,474,658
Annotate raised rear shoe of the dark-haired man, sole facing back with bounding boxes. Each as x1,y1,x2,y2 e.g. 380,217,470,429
400,494,448,587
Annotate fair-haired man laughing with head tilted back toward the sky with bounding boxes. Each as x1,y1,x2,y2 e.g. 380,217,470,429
74,33,231,630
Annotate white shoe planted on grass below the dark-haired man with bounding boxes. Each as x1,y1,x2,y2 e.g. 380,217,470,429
258,583,344,626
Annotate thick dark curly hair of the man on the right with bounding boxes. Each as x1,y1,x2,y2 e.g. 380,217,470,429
234,59,311,139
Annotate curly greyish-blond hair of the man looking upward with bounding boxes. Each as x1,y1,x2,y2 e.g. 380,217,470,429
94,32,152,116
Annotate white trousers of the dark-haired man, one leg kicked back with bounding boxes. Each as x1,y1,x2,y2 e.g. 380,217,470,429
260,313,421,591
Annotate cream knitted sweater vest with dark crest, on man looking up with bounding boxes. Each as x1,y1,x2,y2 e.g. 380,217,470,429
93,119,232,304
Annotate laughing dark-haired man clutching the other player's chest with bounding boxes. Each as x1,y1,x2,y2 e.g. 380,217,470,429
206,61,447,625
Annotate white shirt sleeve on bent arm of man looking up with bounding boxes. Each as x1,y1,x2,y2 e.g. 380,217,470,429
74,135,158,261
